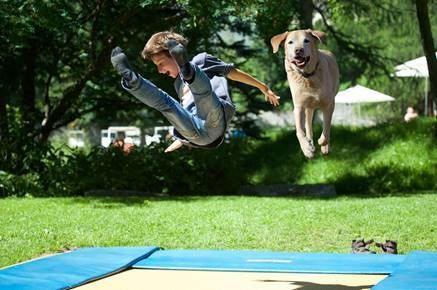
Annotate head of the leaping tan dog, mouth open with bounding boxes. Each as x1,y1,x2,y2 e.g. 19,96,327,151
270,29,325,72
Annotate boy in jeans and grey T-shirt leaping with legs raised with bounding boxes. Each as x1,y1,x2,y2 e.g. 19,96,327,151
111,31,279,152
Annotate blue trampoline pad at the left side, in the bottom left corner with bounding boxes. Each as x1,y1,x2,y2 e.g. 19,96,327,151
0,247,159,290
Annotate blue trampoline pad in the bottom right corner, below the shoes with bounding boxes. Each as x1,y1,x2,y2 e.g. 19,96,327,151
372,252,437,290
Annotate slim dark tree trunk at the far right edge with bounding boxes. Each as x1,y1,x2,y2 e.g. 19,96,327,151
416,0,437,116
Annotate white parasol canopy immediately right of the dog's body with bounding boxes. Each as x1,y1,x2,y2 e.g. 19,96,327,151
335,85,395,104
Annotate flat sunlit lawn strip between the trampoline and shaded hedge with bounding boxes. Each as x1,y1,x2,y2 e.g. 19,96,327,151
0,192,437,267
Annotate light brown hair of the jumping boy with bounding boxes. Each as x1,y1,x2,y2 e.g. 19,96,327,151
141,31,188,59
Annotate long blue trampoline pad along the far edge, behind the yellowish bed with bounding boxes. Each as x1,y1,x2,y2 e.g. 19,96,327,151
132,250,405,274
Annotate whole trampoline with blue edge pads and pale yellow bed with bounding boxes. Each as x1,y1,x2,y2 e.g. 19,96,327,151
0,247,437,290
